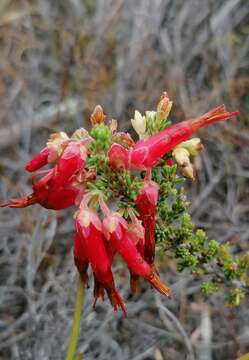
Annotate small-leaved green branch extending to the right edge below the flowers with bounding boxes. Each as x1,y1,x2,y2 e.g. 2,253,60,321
153,165,249,305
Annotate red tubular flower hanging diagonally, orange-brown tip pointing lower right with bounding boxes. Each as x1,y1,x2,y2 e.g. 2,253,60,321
100,199,170,296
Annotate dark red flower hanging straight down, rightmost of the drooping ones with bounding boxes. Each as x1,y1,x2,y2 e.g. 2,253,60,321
136,180,158,264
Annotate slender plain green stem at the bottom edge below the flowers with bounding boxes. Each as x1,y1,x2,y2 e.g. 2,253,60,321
65,278,85,360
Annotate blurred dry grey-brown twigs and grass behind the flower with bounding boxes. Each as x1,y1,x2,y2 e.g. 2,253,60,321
0,0,249,360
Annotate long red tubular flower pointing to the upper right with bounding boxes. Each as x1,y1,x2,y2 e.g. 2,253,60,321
129,105,239,170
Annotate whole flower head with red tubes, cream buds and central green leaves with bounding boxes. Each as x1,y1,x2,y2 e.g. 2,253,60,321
1,93,243,315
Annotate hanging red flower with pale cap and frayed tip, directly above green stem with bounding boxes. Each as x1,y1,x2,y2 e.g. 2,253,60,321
75,206,126,316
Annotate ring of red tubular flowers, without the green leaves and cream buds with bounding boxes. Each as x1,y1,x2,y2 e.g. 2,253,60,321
1,93,237,314
